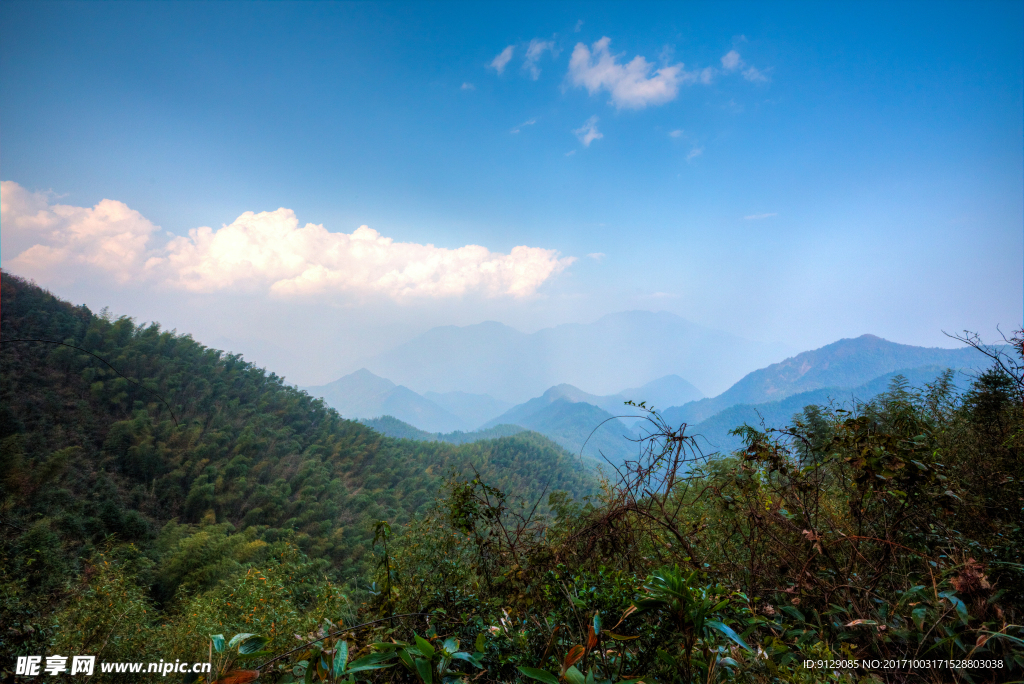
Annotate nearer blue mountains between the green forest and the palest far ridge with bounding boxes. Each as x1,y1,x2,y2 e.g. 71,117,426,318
307,333,987,464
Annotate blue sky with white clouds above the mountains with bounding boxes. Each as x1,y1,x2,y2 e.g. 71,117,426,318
0,2,1024,383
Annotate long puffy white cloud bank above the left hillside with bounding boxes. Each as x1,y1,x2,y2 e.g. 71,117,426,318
0,181,574,299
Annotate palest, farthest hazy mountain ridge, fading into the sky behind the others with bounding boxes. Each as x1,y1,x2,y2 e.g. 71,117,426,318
365,311,785,403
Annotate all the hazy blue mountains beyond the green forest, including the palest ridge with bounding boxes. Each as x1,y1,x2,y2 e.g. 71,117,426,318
303,311,984,465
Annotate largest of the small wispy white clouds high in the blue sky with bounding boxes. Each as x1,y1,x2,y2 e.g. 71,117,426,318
567,37,698,110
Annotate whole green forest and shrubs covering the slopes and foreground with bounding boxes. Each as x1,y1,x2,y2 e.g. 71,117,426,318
0,273,1024,684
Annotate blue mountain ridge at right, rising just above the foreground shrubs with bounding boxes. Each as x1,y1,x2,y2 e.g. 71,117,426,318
662,335,985,425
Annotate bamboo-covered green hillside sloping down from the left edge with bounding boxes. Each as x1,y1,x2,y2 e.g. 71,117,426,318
0,273,596,668
